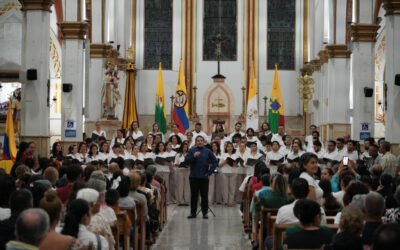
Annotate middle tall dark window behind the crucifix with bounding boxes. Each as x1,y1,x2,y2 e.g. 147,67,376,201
203,0,237,61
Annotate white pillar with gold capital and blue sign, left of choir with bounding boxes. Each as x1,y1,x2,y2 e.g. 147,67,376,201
59,1,89,142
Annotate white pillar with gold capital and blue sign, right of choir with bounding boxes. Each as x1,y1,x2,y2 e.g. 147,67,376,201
350,0,379,143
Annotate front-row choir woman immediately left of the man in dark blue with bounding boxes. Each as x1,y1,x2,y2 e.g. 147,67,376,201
174,142,190,205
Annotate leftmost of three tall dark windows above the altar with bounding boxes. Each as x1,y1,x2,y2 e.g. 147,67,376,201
144,0,172,69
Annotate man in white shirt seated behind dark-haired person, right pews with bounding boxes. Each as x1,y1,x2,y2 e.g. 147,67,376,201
275,178,326,225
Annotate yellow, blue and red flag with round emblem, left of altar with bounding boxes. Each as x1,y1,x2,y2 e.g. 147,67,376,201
172,59,189,134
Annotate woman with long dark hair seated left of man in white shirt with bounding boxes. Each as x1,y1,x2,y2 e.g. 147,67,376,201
255,174,293,211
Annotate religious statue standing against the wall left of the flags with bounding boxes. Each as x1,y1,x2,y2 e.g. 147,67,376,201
101,70,122,120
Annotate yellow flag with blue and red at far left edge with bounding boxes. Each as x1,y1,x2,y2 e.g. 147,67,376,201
3,99,17,161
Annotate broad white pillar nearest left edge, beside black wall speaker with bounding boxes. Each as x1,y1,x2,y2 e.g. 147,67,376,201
20,0,53,156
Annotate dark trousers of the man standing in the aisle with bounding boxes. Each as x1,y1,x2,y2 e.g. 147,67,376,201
189,178,208,215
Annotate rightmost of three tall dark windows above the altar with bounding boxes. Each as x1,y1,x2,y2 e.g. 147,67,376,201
267,0,296,70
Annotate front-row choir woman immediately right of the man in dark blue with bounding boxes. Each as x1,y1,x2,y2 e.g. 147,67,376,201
217,142,238,206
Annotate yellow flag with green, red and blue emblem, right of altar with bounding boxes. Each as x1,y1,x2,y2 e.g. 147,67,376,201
268,64,285,133
